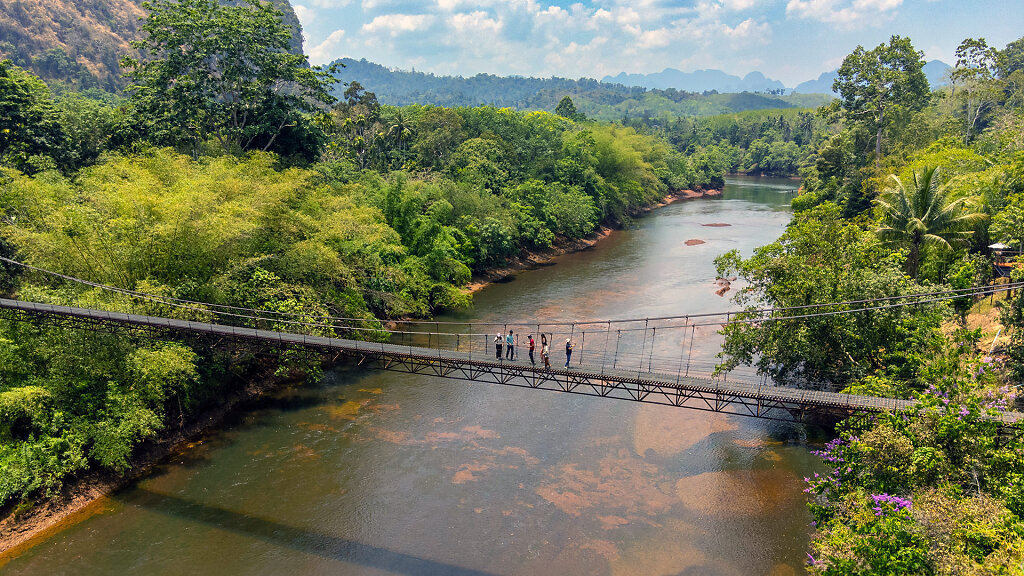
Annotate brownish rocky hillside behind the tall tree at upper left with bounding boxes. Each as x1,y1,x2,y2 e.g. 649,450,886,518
0,0,302,90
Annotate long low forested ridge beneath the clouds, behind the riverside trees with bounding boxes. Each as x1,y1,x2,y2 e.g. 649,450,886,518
338,58,827,121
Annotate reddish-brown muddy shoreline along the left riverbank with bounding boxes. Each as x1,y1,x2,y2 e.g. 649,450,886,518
0,190,721,557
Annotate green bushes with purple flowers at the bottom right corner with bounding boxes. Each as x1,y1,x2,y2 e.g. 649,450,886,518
805,351,1024,575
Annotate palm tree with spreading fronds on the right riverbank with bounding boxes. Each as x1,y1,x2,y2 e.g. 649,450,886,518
874,166,987,279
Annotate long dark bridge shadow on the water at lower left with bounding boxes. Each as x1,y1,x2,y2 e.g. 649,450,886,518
124,488,490,576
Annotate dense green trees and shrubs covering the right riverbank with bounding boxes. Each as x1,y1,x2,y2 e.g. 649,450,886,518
718,37,1024,575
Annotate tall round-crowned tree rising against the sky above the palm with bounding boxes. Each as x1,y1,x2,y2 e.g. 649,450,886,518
833,36,930,165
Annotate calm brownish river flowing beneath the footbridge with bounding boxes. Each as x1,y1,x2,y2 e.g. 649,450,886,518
0,178,820,576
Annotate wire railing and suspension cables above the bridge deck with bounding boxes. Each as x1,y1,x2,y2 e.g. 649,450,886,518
0,257,1024,388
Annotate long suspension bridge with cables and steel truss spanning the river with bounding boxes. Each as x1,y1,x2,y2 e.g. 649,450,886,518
0,257,1024,425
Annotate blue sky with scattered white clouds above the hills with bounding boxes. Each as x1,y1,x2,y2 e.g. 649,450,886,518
292,0,1024,87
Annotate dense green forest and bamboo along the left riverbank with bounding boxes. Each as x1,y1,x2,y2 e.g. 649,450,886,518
0,0,721,511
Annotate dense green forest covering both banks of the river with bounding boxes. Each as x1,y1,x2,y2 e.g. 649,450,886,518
6,0,1024,575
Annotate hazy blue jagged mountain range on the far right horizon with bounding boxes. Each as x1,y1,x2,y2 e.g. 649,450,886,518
601,60,951,95
